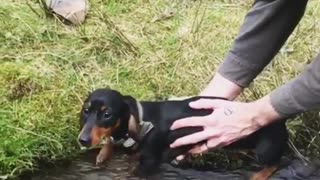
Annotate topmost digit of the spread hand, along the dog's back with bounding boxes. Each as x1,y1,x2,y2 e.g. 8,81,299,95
189,98,229,109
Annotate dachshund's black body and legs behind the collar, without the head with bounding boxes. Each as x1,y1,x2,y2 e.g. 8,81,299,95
135,97,288,178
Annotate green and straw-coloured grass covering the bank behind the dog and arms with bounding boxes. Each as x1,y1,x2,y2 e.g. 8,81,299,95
0,0,320,179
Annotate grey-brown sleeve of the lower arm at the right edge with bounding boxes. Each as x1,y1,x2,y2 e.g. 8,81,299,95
270,54,320,117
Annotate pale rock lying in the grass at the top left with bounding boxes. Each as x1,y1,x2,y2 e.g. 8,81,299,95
47,0,89,25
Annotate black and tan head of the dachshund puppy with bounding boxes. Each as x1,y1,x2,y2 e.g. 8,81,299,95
78,89,135,147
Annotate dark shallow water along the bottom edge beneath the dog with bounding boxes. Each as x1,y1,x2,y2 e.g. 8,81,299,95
23,149,320,180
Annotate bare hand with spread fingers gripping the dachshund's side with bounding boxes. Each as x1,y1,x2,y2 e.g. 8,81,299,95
170,96,280,154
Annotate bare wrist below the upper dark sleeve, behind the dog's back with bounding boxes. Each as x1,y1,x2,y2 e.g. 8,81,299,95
200,73,243,100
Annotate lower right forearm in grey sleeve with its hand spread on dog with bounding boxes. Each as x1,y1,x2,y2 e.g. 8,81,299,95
171,54,320,153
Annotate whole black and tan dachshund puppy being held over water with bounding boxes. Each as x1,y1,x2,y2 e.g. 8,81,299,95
79,89,288,180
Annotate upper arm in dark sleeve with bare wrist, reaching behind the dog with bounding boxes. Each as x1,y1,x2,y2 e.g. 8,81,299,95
200,0,307,100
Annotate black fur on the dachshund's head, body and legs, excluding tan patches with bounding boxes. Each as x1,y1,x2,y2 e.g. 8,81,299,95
80,89,288,176
